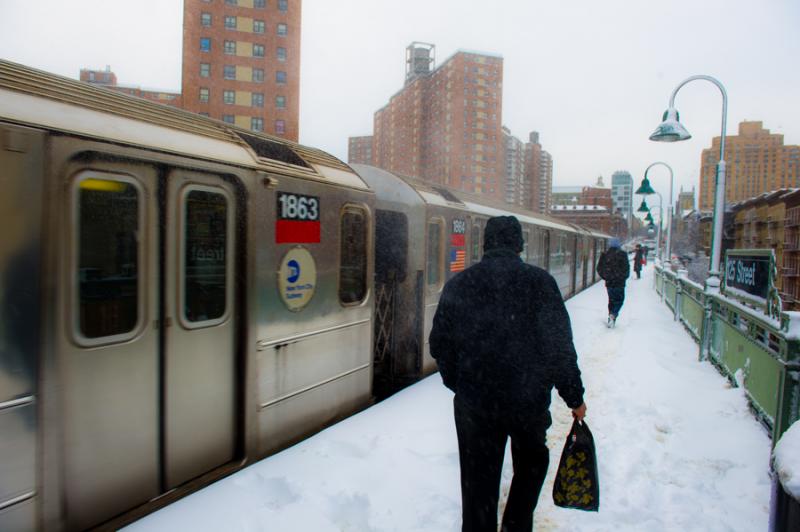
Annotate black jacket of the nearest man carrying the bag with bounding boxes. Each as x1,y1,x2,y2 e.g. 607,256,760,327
430,249,583,425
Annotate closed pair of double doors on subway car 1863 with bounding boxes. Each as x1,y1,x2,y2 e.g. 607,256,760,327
58,160,236,529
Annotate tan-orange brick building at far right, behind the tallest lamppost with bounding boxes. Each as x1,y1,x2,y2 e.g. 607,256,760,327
699,122,800,211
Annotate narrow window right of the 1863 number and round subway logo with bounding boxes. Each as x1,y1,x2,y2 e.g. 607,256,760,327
339,205,367,305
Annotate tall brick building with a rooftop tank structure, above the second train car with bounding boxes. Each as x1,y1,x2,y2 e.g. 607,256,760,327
373,43,505,201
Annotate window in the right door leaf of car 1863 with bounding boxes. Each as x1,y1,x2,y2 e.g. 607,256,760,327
182,189,229,323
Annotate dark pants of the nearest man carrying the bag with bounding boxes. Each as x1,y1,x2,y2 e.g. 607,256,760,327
453,396,550,532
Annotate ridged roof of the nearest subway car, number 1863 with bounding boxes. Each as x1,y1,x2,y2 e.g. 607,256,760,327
0,60,369,190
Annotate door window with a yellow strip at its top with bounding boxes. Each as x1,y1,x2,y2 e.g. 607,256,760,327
75,174,143,344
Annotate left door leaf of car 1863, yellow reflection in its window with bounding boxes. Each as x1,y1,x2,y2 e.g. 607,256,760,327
58,164,161,530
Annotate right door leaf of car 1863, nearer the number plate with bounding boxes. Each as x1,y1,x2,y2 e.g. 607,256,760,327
164,172,237,489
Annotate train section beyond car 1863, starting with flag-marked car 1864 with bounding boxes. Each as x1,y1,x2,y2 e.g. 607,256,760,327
353,164,608,398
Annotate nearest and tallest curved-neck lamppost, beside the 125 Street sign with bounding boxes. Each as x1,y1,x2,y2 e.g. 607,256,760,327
650,75,728,287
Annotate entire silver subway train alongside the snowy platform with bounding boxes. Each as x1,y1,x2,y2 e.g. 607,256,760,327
0,61,608,531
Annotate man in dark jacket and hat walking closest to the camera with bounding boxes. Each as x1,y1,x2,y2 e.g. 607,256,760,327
430,216,586,532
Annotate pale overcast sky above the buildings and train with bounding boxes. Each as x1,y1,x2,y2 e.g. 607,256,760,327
0,0,800,206
